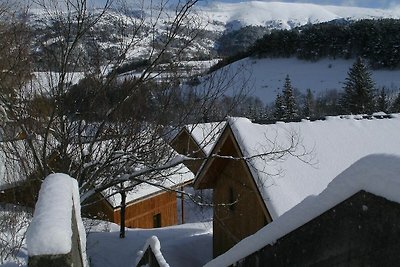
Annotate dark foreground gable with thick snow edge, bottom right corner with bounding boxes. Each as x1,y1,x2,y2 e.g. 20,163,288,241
205,154,400,267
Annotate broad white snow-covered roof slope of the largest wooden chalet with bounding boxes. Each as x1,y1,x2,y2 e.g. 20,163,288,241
228,115,400,220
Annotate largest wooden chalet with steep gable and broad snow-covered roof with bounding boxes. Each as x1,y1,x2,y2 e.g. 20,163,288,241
194,115,400,257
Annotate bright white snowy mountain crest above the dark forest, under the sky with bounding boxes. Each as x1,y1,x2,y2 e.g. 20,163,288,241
198,1,400,30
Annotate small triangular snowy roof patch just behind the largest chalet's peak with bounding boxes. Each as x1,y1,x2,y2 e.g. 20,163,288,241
185,121,225,155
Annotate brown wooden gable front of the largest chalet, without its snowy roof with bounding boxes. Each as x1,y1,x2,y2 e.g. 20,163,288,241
194,123,271,257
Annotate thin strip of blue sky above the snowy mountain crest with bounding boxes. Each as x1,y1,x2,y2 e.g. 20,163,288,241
200,0,400,8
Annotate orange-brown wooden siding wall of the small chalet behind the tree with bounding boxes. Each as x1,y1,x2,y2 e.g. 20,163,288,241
114,192,178,228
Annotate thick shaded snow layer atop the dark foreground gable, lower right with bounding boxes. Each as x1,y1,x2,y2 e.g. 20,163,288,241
205,154,400,267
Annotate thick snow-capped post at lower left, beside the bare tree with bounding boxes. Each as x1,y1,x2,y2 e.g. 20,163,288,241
27,174,87,267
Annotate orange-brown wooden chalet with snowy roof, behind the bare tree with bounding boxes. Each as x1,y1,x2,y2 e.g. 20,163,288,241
82,166,194,228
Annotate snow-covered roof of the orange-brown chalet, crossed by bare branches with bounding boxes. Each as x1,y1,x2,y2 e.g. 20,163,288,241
102,164,194,208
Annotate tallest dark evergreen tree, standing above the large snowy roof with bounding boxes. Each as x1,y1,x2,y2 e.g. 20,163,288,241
341,57,374,114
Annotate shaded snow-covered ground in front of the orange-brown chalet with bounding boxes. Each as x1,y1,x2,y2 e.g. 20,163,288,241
87,222,212,267
